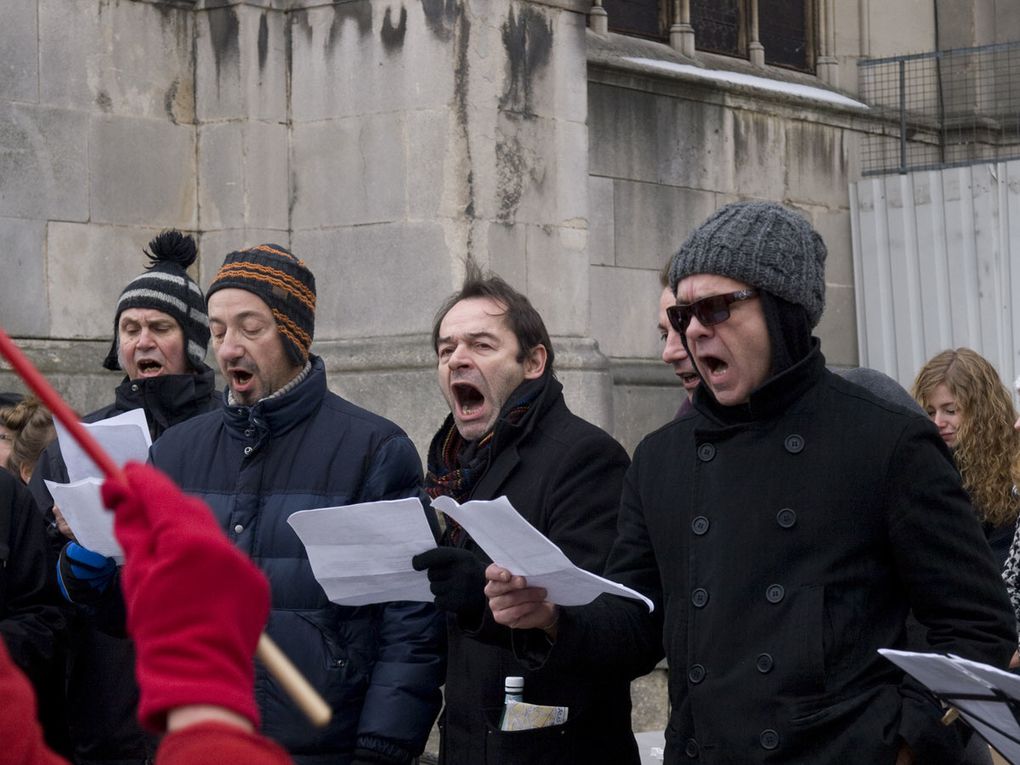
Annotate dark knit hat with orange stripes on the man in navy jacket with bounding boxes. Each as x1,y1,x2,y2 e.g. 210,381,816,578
208,244,315,366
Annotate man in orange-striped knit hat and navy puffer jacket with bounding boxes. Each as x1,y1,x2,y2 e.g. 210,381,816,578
151,244,443,765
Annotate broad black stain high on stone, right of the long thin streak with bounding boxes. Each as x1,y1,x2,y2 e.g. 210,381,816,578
500,7,553,115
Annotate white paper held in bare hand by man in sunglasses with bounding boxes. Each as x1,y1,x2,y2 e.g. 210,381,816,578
432,497,655,611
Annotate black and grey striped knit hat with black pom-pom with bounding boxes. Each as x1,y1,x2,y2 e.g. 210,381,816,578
103,230,209,370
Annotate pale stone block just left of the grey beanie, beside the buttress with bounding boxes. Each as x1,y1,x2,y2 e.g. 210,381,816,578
589,267,662,358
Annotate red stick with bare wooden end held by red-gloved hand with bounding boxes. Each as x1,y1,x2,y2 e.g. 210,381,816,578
0,329,333,727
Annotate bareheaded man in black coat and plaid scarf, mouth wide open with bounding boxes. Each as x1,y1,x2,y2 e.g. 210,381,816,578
414,261,638,765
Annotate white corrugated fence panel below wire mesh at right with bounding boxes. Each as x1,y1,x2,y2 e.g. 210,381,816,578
850,160,1020,391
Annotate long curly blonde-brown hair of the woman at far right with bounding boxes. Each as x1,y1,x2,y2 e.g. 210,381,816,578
911,348,1020,526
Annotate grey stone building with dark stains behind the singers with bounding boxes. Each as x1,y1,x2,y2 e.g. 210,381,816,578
0,0,1020,750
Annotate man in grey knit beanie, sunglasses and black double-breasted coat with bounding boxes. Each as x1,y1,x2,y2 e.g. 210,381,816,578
487,202,1015,765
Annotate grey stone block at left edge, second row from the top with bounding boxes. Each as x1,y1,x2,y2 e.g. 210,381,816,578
0,103,89,220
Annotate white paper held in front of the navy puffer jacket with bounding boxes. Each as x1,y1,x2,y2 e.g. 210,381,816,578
287,498,436,606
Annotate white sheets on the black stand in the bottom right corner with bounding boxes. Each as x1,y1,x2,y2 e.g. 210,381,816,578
878,649,1020,762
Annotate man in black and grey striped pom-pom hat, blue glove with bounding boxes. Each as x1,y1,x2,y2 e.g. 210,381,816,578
30,231,218,765
